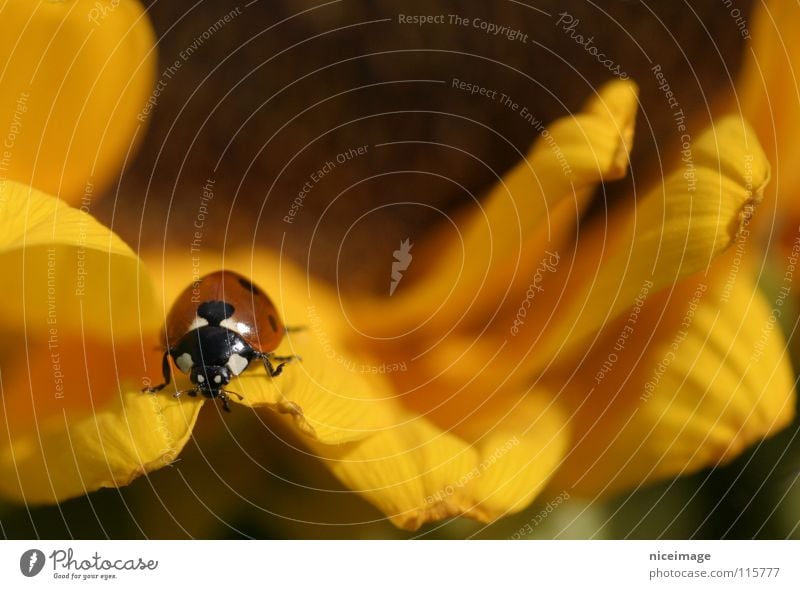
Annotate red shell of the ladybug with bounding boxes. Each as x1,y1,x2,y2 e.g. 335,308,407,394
163,270,286,352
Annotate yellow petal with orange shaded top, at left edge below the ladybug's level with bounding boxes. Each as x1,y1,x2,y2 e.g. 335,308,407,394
0,334,201,503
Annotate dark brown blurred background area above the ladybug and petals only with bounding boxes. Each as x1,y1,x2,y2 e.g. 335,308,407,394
100,0,749,293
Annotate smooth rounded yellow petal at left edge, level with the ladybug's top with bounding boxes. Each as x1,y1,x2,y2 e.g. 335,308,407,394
0,182,159,338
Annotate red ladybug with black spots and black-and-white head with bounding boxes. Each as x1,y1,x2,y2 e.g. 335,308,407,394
142,270,298,411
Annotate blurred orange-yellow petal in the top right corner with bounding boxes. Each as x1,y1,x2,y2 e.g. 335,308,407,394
732,0,800,223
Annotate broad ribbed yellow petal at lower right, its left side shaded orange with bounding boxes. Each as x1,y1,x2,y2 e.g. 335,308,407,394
550,257,795,494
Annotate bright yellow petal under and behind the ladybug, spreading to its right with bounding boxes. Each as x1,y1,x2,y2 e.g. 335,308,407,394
150,251,394,444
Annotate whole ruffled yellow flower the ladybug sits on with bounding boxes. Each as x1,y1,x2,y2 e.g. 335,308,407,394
0,3,794,529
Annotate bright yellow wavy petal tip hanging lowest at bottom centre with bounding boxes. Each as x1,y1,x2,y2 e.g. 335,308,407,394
311,388,568,530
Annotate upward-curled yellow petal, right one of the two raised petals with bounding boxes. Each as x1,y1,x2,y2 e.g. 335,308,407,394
519,117,769,366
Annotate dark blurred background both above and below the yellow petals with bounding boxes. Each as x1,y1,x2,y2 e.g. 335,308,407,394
6,0,800,538
